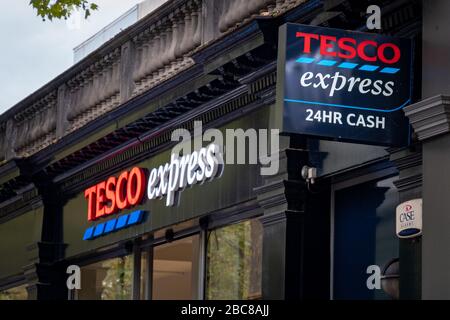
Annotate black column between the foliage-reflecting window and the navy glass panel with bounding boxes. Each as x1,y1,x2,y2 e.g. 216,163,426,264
255,137,330,299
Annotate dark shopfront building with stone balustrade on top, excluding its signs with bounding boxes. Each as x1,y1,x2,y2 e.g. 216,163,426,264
0,0,449,300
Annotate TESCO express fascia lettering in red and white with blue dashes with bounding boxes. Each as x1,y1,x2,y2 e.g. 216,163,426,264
83,144,224,240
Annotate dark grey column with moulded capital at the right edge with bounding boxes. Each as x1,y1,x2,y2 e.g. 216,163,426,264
405,95,450,299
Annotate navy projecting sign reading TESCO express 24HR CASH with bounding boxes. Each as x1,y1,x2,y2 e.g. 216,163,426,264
277,23,412,146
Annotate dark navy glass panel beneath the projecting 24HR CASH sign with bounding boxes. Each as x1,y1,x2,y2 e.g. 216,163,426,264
333,178,399,300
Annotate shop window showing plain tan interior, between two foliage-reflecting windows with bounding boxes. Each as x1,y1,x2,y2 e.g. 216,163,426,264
152,235,201,300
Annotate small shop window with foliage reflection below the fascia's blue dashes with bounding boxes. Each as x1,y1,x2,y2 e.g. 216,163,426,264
77,256,133,300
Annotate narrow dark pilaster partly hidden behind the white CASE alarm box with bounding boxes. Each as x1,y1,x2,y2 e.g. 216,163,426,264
389,143,422,300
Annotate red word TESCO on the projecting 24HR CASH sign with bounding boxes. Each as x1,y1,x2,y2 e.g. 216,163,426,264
296,32,401,64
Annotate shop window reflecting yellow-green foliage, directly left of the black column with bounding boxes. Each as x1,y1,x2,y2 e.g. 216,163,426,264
206,219,262,300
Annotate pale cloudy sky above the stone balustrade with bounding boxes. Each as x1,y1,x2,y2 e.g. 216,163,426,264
0,0,142,114
